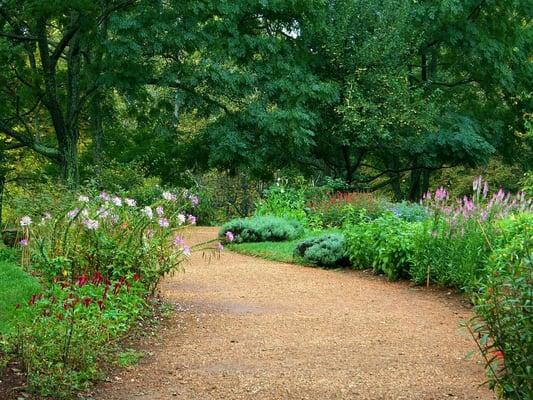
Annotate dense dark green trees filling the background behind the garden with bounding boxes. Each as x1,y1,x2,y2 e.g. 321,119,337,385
0,0,533,223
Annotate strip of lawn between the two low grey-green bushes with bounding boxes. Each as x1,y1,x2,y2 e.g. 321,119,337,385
227,229,339,265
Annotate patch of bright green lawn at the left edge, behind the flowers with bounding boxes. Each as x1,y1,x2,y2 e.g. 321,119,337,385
0,253,40,335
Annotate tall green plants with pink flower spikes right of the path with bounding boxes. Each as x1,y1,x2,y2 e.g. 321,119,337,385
411,178,532,292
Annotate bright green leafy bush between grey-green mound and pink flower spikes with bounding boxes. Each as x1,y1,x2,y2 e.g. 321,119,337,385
344,214,419,280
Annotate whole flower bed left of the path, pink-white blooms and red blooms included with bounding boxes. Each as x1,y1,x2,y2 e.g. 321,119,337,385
3,192,222,399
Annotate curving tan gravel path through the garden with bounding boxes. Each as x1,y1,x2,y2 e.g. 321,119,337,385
94,228,493,400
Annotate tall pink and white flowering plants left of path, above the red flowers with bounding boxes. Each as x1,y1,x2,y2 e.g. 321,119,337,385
20,192,214,291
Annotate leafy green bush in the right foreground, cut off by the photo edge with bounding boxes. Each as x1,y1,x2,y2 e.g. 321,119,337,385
470,213,533,400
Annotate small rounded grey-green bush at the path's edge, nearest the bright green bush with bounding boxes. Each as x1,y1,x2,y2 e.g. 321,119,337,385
294,233,350,267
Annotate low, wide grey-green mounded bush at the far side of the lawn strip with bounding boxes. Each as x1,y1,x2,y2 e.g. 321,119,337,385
220,216,304,243
